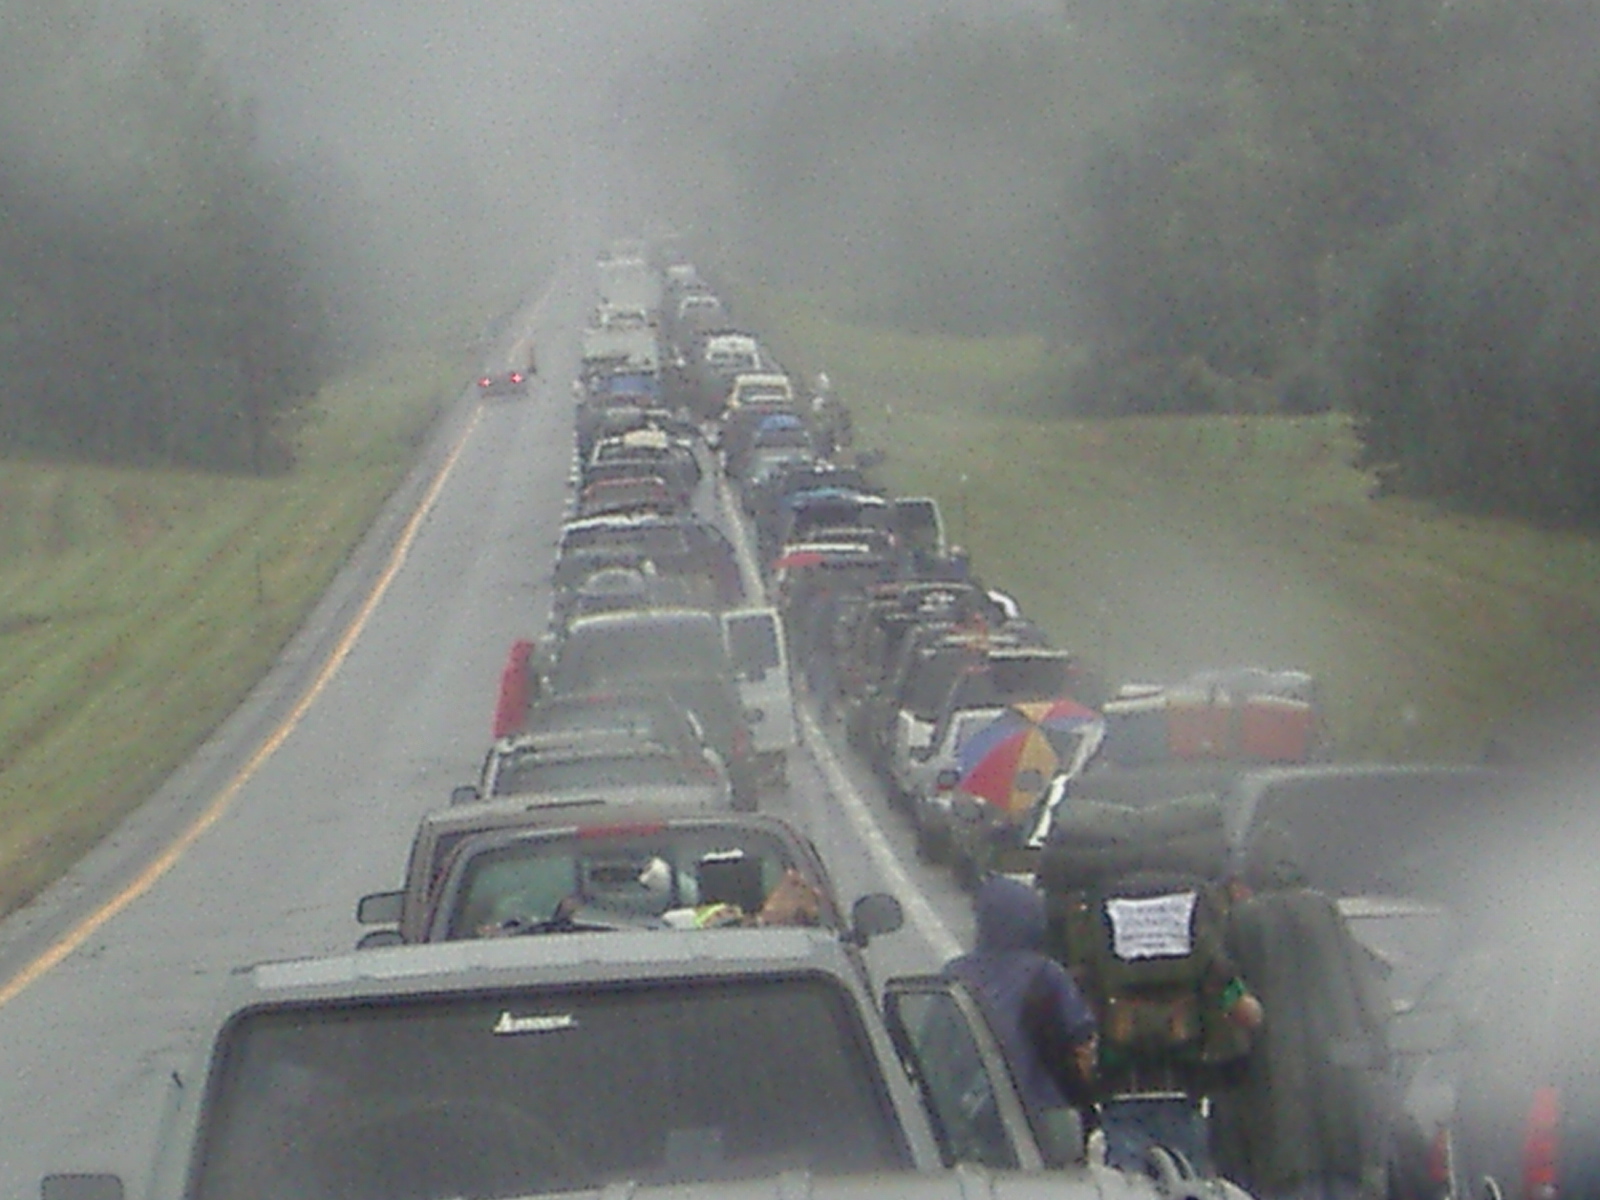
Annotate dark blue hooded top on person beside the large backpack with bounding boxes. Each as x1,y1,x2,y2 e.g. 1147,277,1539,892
944,875,1094,1114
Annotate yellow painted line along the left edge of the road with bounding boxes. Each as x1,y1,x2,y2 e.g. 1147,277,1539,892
0,405,483,1006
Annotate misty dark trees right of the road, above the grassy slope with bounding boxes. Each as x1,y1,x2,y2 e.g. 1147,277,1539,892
637,0,1600,528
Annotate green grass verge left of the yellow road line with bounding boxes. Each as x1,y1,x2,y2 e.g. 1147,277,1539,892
0,352,469,914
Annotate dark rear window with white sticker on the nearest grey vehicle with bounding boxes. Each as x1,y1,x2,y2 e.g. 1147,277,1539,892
190,978,909,1200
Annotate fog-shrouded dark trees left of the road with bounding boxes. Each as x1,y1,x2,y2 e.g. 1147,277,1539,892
0,0,330,474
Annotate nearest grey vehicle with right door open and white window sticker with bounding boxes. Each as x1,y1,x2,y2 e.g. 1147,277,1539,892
42,928,1229,1200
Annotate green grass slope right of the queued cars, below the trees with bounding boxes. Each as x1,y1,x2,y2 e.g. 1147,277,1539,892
741,294,1600,760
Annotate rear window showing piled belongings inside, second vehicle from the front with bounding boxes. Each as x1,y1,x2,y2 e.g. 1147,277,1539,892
438,826,798,939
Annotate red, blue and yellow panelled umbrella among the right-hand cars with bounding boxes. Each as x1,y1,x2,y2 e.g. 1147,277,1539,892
957,696,1104,818
